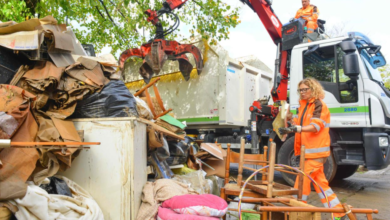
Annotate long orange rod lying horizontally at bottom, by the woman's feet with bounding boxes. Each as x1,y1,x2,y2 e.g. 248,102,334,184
260,206,378,214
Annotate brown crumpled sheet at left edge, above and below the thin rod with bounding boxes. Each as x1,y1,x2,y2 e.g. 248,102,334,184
0,85,39,201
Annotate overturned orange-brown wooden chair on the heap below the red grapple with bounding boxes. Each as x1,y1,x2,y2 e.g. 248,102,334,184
134,77,172,120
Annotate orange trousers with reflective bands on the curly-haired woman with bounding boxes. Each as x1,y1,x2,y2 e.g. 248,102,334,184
294,159,345,217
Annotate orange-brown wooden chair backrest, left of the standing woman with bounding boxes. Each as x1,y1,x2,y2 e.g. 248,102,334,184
225,144,268,185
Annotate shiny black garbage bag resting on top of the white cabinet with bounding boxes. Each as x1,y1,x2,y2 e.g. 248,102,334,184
73,80,138,118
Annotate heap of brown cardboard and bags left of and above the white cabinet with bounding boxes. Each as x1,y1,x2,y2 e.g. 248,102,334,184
0,16,138,219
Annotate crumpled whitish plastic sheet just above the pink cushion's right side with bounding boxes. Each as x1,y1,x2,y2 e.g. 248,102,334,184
173,170,212,194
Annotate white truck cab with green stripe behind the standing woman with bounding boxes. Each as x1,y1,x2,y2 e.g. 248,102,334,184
278,32,390,182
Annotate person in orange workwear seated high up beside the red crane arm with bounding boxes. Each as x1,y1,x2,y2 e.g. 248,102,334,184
295,0,320,33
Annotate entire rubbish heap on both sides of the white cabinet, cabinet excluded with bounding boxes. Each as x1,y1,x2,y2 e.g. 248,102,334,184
0,16,227,219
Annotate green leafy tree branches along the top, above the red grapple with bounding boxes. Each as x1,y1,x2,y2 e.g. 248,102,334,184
0,0,240,54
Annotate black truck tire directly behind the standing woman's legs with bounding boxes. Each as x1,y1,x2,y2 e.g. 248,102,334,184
277,136,337,186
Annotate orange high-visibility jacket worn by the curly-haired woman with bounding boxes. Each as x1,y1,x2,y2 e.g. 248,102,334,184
293,98,330,159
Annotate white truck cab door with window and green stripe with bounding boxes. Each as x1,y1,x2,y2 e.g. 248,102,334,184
302,45,368,128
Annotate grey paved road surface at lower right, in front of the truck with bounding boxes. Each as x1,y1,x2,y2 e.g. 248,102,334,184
227,166,390,220
